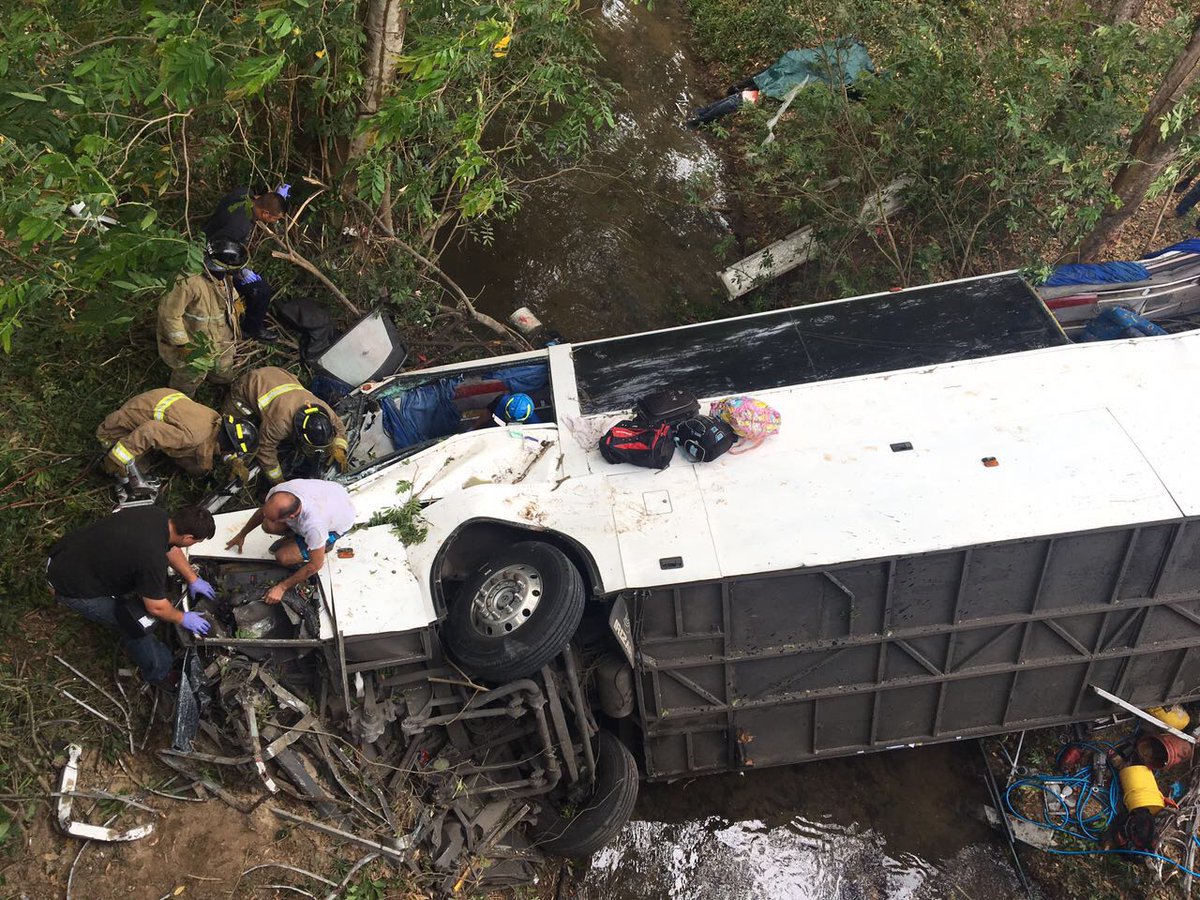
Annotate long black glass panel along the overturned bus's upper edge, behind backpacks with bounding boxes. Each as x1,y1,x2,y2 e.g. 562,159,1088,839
572,272,1068,415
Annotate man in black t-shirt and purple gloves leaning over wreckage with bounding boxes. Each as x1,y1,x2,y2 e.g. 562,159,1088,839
46,506,216,683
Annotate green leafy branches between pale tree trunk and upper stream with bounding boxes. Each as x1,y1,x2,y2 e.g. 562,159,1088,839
356,0,613,240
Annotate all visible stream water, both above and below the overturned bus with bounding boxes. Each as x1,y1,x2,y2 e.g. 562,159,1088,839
443,0,1024,900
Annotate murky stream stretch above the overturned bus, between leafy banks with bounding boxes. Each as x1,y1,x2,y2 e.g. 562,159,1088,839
442,0,742,341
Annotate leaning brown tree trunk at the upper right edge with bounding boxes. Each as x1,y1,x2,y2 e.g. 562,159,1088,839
1079,17,1200,263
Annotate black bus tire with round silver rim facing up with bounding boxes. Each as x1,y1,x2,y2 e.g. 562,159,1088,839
442,541,584,683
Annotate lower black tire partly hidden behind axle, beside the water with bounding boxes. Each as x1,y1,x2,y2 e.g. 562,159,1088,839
533,731,637,859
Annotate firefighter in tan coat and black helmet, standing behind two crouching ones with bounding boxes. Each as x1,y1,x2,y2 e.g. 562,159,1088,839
158,241,246,396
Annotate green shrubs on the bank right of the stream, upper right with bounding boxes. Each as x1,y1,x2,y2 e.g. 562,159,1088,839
689,0,1192,293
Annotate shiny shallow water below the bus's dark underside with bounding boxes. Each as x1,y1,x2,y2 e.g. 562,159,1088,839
584,742,1024,900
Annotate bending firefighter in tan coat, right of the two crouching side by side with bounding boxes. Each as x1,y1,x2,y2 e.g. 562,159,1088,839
229,366,347,485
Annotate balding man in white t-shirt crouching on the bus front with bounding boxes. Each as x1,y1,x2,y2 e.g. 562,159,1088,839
226,478,354,604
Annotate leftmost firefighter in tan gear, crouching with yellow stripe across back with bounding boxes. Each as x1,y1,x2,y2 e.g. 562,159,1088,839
96,388,257,491
